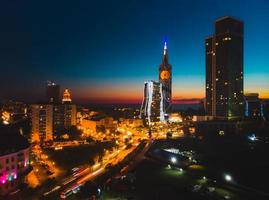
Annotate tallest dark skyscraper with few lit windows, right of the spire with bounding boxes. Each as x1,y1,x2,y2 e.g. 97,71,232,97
205,17,244,119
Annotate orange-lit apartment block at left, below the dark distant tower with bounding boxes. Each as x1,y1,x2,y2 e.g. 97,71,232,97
31,104,53,144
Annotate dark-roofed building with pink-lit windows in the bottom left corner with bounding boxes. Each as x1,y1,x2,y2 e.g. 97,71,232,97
0,130,31,196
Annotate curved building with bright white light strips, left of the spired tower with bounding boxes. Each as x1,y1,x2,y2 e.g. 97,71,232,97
140,81,165,125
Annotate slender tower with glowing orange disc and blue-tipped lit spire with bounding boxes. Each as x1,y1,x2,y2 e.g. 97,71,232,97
159,42,172,113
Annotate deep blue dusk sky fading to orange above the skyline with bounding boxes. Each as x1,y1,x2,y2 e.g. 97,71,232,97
0,0,269,103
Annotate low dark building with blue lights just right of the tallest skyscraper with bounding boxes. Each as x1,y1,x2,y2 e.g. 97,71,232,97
244,93,264,118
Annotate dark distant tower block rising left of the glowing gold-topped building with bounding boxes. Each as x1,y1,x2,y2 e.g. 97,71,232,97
46,81,60,103
